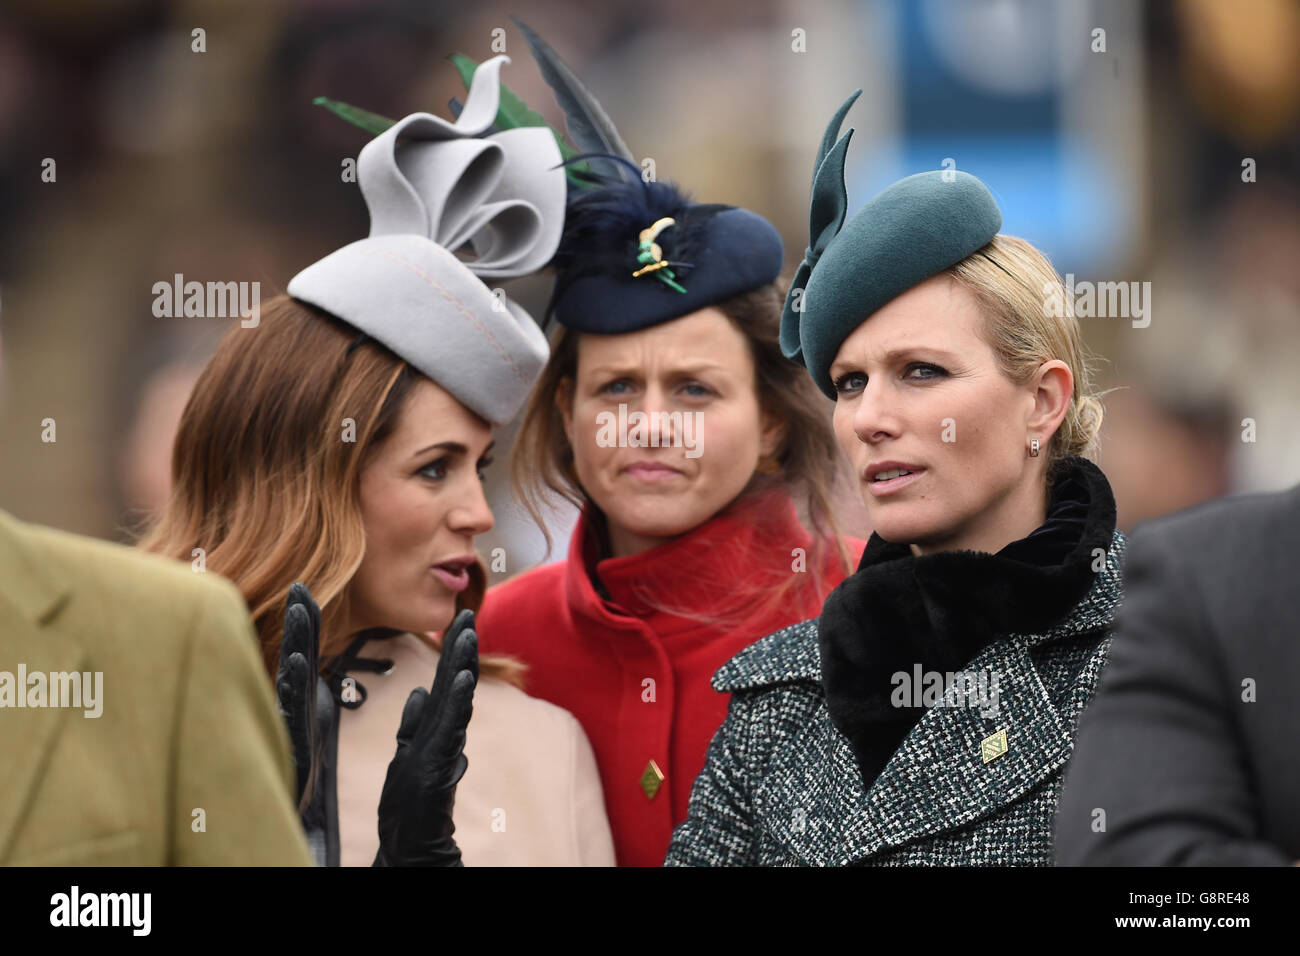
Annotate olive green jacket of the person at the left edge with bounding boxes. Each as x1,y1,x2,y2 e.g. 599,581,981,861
0,511,312,865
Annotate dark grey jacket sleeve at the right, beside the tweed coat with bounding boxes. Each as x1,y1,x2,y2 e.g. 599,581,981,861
1054,528,1292,866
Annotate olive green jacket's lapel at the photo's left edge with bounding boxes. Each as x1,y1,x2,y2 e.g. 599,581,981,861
0,512,86,864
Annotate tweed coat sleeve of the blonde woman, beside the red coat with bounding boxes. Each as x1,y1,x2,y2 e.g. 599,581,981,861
664,693,758,866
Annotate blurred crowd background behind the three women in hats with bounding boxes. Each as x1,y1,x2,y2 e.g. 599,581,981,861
0,0,1300,574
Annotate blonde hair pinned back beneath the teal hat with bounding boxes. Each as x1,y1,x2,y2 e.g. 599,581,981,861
948,235,1102,479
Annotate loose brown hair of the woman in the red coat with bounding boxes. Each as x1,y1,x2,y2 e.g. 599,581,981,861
511,282,853,617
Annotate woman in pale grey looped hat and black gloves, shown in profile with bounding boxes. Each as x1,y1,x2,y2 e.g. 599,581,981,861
142,57,612,865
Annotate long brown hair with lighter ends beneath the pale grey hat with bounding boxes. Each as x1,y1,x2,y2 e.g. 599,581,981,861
139,295,522,679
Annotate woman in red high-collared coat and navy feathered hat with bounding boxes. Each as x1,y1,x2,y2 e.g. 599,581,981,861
478,160,865,865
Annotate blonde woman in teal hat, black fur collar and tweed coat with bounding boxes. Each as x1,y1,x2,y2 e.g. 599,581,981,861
667,94,1125,865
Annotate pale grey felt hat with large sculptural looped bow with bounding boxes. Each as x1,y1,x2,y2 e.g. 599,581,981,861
287,56,567,425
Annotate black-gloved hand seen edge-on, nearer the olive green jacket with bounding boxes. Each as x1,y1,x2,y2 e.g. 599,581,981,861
276,584,334,865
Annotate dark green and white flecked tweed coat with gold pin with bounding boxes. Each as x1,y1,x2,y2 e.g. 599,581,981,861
664,531,1125,866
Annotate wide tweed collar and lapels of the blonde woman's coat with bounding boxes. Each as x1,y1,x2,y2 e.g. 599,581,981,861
733,531,1125,866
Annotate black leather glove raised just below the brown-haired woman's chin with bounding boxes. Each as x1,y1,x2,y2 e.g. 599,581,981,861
374,610,478,866
